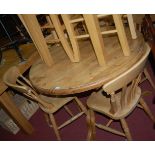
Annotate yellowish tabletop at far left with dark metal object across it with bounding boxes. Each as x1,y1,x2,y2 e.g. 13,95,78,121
0,43,36,79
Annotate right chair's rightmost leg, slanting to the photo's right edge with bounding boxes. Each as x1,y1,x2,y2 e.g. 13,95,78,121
139,98,155,123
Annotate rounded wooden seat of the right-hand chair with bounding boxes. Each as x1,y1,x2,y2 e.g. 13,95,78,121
87,87,141,120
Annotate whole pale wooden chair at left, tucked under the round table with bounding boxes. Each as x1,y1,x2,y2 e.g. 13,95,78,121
3,66,87,140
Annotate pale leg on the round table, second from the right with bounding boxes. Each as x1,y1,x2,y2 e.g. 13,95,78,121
113,14,130,56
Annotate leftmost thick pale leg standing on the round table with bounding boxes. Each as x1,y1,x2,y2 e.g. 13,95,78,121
21,14,53,66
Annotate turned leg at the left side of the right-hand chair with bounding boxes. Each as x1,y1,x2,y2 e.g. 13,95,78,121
86,110,96,140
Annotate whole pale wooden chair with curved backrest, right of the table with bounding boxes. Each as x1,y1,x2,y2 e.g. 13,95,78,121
87,46,155,140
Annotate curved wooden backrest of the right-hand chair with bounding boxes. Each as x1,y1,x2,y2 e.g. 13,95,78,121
103,45,150,114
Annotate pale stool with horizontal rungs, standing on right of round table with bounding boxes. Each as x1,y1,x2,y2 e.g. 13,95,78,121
61,14,130,66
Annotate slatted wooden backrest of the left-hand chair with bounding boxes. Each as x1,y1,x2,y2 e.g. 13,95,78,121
3,66,53,108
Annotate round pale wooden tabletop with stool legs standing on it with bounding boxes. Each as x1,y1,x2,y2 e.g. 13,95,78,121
29,30,148,95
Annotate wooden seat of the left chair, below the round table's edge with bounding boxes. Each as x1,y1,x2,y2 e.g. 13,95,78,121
39,95,74,113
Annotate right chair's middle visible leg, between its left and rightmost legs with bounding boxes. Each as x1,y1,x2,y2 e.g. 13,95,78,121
120,118,132,140
